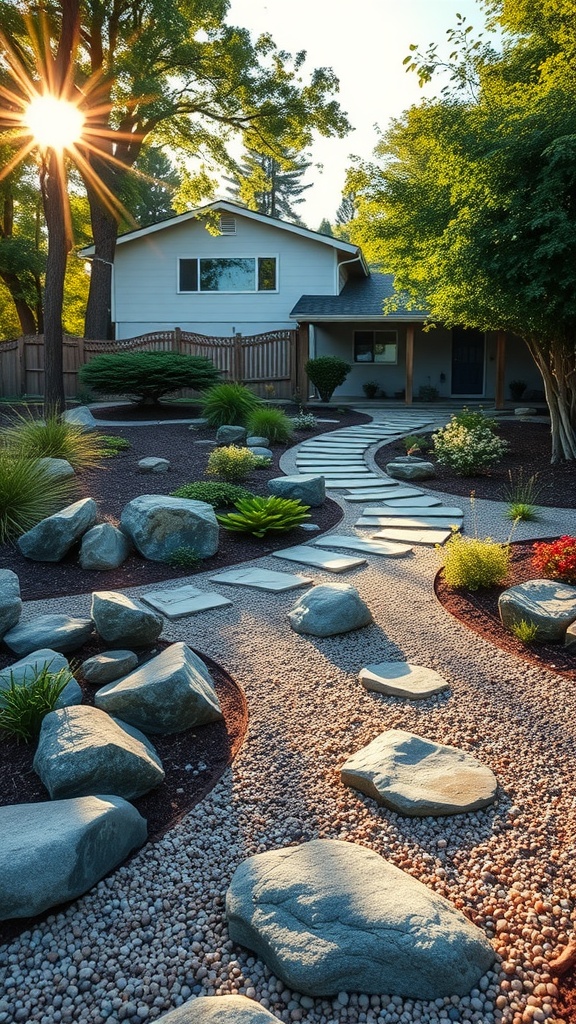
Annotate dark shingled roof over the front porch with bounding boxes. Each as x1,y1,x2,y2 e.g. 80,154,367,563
290,272,427,323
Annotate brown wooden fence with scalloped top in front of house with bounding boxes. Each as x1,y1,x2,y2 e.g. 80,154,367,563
0,328,307,398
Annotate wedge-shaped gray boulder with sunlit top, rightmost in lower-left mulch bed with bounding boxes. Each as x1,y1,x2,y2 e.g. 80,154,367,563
94,643,222,734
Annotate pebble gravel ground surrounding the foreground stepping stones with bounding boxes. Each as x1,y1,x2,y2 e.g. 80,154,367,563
0,411,576,1024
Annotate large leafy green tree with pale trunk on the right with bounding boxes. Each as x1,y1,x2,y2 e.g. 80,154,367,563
348,0,576,461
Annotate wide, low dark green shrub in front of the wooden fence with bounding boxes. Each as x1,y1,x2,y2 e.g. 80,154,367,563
78,352,219,404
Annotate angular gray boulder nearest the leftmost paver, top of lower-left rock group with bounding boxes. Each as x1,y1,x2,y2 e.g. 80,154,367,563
90,590,164,647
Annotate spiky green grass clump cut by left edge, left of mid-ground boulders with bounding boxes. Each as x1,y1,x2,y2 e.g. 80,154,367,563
0,451,74,544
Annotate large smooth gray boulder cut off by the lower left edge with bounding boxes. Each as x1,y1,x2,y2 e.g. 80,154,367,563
0,797,148,921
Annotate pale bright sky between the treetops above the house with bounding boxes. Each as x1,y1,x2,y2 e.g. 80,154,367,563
228,0,484,230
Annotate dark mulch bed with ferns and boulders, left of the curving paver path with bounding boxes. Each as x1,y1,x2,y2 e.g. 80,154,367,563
0,406,370,601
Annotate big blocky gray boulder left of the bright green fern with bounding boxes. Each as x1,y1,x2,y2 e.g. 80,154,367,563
120,495,218,562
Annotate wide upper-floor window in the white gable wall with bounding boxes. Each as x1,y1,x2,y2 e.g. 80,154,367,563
178,256,278,292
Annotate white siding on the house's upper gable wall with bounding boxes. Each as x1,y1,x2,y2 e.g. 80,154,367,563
115,216,336,338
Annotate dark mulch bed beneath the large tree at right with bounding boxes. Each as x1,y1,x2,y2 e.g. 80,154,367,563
376,420,576,508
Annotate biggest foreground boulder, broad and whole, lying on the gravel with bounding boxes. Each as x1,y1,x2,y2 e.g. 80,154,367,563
227,840,494,999
